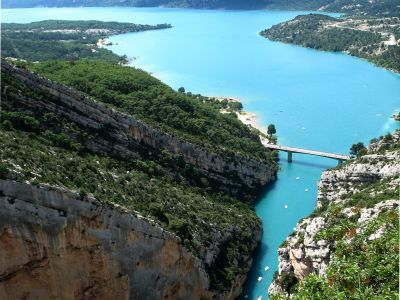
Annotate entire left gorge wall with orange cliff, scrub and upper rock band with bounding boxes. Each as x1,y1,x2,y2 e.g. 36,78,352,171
0,60,276,299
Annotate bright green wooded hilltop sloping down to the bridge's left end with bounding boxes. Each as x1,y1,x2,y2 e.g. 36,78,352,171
23,61,276,166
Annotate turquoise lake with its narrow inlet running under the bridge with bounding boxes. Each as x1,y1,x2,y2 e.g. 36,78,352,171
2,8,400,299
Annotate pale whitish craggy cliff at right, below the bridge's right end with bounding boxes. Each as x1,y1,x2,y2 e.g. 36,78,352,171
268,131,400,296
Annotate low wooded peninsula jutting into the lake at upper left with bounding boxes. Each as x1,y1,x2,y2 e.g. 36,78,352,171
1,20,171,63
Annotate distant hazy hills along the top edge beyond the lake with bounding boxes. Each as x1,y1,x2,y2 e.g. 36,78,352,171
2,0,400,16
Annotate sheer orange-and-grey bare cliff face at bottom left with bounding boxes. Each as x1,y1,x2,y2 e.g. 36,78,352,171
0,180,216,299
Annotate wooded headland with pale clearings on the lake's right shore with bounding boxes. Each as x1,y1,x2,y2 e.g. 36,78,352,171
261,14,400,72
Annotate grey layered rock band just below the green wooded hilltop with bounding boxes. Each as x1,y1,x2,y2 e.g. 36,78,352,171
1,60,276,197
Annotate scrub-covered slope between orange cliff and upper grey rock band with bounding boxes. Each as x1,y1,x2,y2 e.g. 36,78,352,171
0,67,266,289
